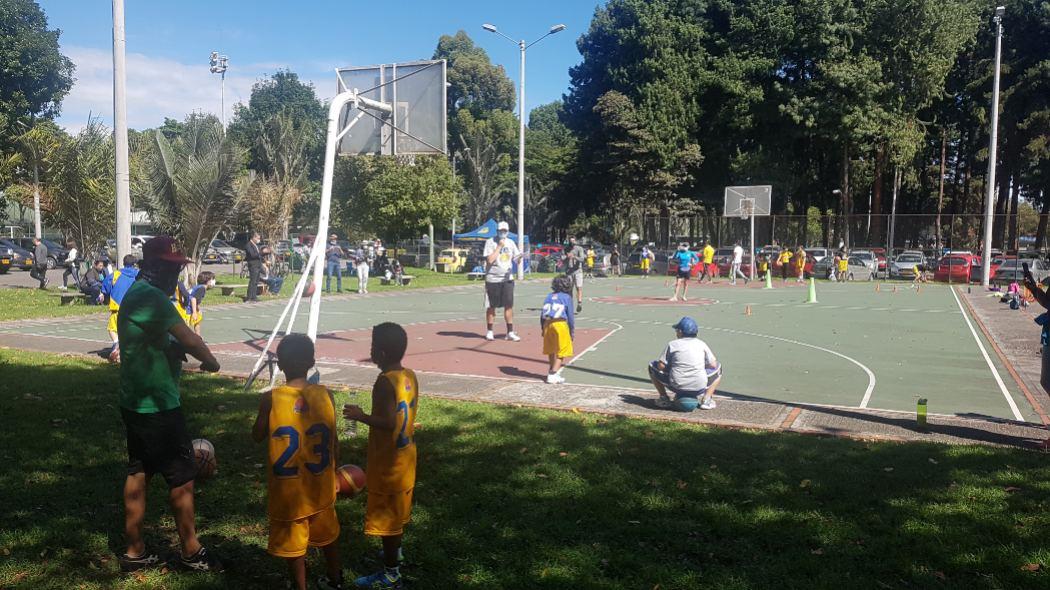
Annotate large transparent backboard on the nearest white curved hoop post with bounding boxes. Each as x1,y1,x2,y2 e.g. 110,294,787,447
336,60,447,155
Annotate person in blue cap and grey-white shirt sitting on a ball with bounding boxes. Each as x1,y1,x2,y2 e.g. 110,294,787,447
649,316,721,410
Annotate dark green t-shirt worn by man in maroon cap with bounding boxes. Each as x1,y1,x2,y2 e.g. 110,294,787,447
117,280,183,414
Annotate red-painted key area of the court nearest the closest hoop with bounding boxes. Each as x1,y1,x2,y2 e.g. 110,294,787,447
212,317,611,380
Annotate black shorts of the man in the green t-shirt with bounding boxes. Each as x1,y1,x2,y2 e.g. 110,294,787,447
121,407,197,488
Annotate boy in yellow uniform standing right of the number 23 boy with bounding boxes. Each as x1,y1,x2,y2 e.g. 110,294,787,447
342,322,419,589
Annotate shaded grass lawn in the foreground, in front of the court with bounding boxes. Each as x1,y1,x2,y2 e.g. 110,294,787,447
0,351,1050,590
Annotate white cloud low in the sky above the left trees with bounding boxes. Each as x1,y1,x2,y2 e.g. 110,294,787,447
59,46,334,131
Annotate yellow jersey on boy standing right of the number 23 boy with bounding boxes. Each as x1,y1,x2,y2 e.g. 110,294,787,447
365,368,419,493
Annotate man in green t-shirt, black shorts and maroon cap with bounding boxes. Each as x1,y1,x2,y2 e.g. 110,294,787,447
117,236,223,571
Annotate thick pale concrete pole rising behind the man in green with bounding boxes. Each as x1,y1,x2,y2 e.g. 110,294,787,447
111,0,131,260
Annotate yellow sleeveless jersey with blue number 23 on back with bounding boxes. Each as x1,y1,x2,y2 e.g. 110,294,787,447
267,385,336,521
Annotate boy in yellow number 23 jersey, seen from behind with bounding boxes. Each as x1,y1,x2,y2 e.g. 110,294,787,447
252,334,342,590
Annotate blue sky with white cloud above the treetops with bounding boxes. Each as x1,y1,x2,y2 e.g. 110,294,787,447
39,0,600,129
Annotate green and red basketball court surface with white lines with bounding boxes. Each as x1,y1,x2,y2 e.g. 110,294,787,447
3,277,1040,422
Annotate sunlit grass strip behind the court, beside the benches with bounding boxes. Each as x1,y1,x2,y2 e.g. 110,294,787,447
0,265,554,321
